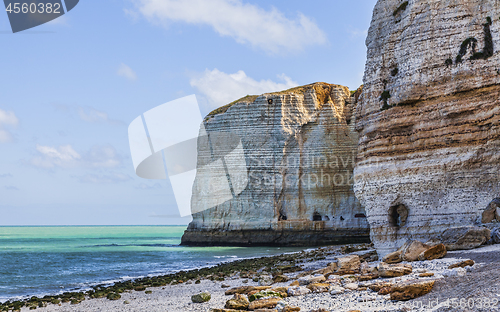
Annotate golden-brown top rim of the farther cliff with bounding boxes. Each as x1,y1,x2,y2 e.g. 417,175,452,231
206,82,356,118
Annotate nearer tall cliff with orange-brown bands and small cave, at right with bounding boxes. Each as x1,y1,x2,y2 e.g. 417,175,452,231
354,0,500,256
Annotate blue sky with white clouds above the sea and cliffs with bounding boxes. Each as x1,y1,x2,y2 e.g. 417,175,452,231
0,0,376,226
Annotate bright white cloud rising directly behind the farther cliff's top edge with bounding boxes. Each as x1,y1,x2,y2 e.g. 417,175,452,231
190,69,298,108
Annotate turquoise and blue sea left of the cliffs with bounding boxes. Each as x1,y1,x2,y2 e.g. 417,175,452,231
0,226,299,301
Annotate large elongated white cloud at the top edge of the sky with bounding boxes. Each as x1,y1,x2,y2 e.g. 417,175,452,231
130,0,326,54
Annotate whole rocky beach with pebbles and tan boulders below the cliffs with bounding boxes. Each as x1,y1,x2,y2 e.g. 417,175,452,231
0,244,500,312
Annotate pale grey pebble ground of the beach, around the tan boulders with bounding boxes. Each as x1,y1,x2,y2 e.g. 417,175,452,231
5,245,500,312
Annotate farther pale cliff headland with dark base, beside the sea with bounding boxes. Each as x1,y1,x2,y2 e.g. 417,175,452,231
182,83,369,246
